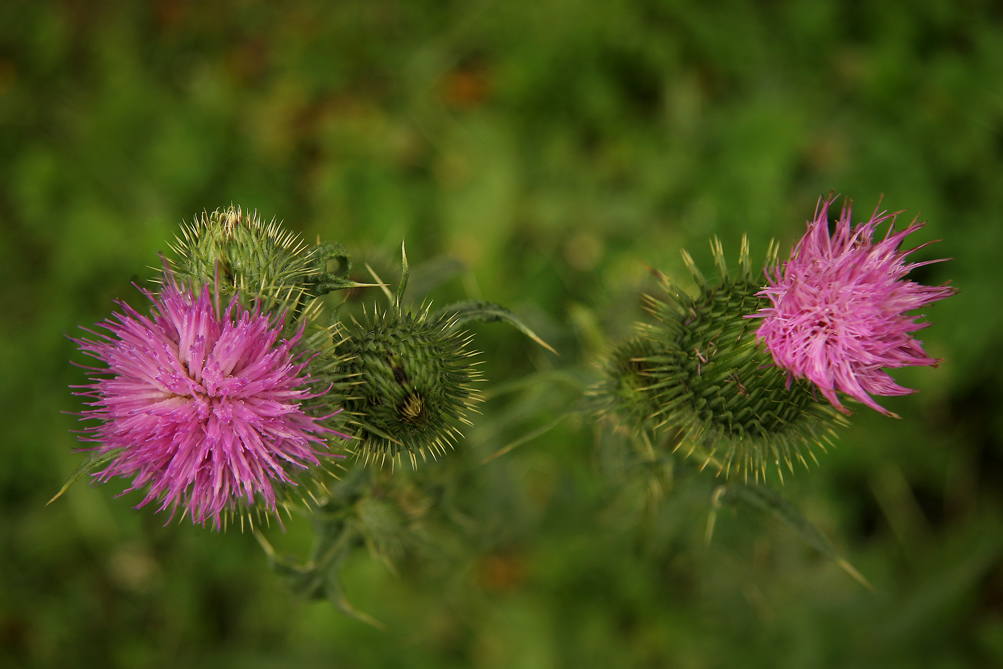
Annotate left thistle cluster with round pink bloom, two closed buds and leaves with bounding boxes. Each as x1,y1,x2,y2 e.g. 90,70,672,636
53,207,546,622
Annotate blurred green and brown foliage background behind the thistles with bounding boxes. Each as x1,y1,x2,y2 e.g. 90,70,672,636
0,0,1003,668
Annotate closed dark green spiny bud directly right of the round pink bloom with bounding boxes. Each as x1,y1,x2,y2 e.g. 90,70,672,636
338,307,479,465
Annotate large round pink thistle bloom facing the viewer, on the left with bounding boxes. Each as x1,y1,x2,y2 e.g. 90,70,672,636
74,279,344,530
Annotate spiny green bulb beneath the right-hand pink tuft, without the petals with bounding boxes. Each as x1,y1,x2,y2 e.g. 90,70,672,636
625,239,845,479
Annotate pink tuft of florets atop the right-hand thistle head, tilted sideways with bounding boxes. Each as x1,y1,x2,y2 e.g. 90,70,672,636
753,198,955,416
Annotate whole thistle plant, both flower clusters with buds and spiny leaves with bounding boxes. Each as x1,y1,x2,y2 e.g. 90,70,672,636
56,199,953,624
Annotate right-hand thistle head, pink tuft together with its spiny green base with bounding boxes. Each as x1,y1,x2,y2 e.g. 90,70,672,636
597,198,954,479
